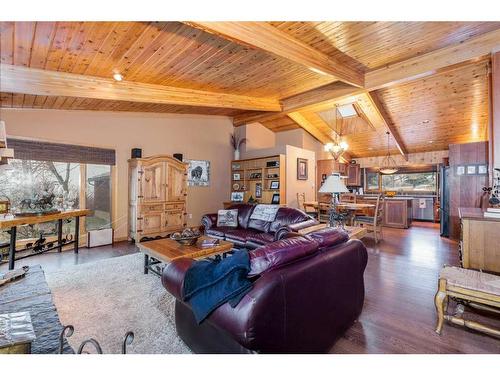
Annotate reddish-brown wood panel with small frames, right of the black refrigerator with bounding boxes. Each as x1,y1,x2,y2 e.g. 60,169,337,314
449,142,488,239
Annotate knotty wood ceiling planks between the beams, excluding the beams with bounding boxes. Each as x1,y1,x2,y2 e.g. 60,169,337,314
0,22,500,157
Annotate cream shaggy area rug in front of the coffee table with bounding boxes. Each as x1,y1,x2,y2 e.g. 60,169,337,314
46,254,190,354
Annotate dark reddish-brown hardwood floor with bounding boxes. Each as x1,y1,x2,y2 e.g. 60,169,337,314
0,222,500,354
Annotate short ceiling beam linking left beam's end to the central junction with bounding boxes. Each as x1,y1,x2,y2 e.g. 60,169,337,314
233,82,364,126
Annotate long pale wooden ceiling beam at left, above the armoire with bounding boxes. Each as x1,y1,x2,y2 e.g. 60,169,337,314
0,64,281,111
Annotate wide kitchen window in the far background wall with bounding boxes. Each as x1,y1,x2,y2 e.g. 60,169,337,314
382,172,437,193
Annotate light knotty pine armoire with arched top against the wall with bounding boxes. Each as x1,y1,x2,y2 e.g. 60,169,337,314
128,155,187,242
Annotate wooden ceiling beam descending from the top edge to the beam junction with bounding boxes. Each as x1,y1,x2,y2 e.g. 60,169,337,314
186,22,364,87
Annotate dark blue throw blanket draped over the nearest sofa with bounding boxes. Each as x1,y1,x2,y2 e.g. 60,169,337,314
183,250,252,324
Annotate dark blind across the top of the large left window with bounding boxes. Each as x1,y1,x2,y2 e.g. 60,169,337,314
7,138,116,165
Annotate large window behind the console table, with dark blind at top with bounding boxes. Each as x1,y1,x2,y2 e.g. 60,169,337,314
0,138,115,243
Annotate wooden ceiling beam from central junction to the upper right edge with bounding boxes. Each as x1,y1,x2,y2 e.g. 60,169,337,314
365,29,500,91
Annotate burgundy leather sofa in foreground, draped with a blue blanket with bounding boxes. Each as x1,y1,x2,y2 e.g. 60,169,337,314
162,228,367,353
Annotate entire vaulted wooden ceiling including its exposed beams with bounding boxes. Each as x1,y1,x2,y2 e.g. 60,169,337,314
0,22,500,157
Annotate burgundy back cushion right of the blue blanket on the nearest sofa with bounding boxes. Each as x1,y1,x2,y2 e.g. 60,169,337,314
248,237,318,276
